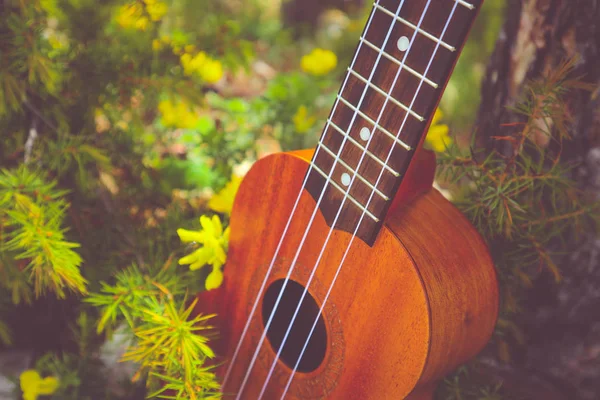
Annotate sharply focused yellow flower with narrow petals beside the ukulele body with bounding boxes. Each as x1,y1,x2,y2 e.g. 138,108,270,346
177,215,229,290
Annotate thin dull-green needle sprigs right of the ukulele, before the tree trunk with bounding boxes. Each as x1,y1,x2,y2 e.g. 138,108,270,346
438,60,600,399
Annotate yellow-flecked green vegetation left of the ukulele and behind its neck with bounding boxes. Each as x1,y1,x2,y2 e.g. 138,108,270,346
0,0,552,400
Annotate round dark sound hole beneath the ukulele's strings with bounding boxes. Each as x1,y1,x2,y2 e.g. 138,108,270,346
262,279,327,372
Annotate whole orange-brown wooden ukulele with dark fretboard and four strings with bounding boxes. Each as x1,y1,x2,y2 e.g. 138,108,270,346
199,0,498,400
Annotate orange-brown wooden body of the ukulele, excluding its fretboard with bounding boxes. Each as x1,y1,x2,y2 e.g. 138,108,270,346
199,151,498,400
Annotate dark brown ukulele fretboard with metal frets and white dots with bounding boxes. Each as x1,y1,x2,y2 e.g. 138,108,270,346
306,0,483,245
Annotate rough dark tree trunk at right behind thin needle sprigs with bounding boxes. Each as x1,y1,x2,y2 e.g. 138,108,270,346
477,0,600,400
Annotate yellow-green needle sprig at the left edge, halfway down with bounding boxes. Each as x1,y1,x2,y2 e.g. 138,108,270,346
0,167,86,304
